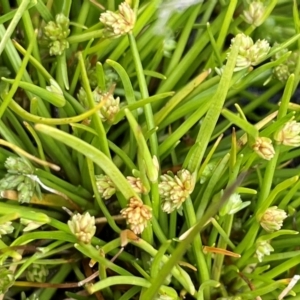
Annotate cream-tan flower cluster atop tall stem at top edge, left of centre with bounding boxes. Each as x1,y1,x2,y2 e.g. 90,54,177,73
100,2,136,38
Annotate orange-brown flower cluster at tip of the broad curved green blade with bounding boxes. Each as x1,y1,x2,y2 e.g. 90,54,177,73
121,197,152,234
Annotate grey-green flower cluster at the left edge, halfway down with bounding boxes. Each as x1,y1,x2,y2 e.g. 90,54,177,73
0,157,36,203
